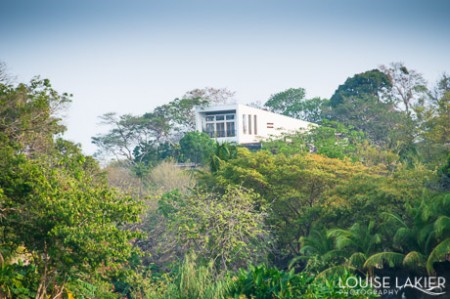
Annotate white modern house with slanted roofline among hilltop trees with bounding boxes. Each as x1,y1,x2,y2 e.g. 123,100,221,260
195,104,316,145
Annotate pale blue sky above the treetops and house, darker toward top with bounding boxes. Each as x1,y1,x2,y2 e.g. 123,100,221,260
0,0,450,154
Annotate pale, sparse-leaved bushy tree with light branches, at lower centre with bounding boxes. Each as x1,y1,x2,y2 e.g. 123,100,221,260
159,186,270,271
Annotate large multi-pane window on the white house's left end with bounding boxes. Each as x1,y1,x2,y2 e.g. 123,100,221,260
204,111,236,138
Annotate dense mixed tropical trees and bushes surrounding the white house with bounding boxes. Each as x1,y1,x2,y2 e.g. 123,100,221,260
0,64,450,299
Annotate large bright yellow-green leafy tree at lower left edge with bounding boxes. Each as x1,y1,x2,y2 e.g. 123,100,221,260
0,141,139,298
